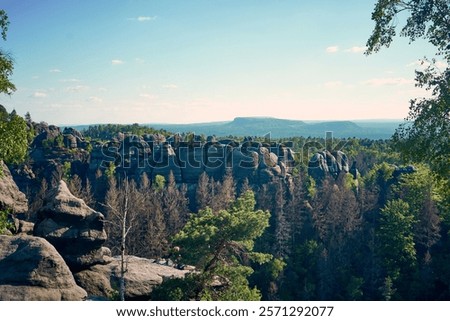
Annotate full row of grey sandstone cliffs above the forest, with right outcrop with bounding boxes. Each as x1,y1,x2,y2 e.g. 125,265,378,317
13,125,356,200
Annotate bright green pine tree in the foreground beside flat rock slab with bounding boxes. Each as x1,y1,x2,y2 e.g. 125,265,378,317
157,191,271,300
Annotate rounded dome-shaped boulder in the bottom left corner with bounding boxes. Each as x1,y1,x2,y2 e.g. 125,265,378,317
0,235,87,301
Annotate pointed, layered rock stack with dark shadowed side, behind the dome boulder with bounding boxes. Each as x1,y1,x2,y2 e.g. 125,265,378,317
34,181,110,270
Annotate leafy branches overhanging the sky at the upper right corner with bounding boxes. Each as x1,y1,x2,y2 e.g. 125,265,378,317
367,0,450,179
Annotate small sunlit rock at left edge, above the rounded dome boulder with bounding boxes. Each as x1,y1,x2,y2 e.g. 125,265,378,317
0,160,28,213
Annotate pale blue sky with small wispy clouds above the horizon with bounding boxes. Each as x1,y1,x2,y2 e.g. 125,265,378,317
0,0,442,125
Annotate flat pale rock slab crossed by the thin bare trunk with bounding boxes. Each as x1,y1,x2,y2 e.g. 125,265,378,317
74,256,189,300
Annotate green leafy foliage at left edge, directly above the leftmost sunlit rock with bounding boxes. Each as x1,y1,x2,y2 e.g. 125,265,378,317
0,106,28,170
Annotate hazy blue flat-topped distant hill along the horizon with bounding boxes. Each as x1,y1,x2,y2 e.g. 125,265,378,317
67,117,402,139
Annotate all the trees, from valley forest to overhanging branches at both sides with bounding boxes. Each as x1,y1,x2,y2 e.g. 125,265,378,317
0,0,450,300
